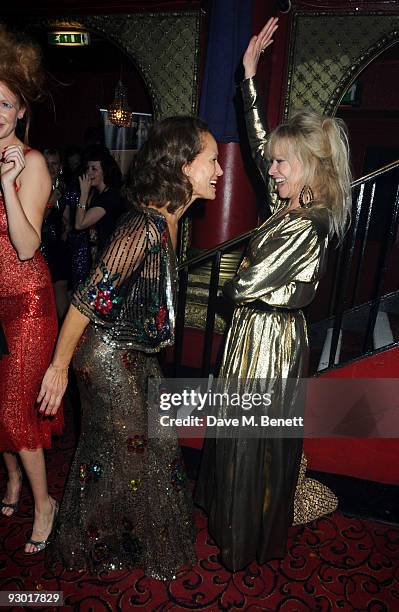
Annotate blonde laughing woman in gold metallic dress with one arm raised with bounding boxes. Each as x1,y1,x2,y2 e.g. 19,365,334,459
195,18,350,571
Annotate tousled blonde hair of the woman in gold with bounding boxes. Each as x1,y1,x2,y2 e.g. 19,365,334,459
267,110,352,242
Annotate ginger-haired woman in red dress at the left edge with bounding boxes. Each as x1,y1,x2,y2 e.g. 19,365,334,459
0,27,62,554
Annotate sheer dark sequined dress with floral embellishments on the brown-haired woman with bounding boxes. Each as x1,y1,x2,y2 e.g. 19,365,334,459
47,209,195,579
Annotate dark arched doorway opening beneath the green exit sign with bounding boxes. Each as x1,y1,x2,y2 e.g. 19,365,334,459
31,30,153,157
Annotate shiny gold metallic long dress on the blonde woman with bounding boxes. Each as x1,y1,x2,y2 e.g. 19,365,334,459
195,79,337,571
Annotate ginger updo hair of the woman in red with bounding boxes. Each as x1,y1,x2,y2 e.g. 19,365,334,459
0,24,45,142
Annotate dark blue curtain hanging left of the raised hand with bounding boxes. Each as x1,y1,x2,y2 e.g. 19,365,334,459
199,0,253,142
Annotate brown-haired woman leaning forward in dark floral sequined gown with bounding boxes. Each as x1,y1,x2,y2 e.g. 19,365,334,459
38,117,222,579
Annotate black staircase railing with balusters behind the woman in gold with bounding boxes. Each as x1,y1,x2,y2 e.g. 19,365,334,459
173,155,399,377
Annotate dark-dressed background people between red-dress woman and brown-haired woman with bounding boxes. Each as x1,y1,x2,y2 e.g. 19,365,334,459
40,144,123,321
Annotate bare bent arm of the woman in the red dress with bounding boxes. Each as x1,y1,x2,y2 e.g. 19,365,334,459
0,145,51,261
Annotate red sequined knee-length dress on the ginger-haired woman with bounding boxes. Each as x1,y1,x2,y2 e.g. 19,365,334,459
0,163,63,452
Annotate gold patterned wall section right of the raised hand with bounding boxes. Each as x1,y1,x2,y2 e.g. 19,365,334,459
284,8,399,117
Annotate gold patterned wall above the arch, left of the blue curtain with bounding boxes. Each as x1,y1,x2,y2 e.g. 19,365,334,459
29,11,200,119
